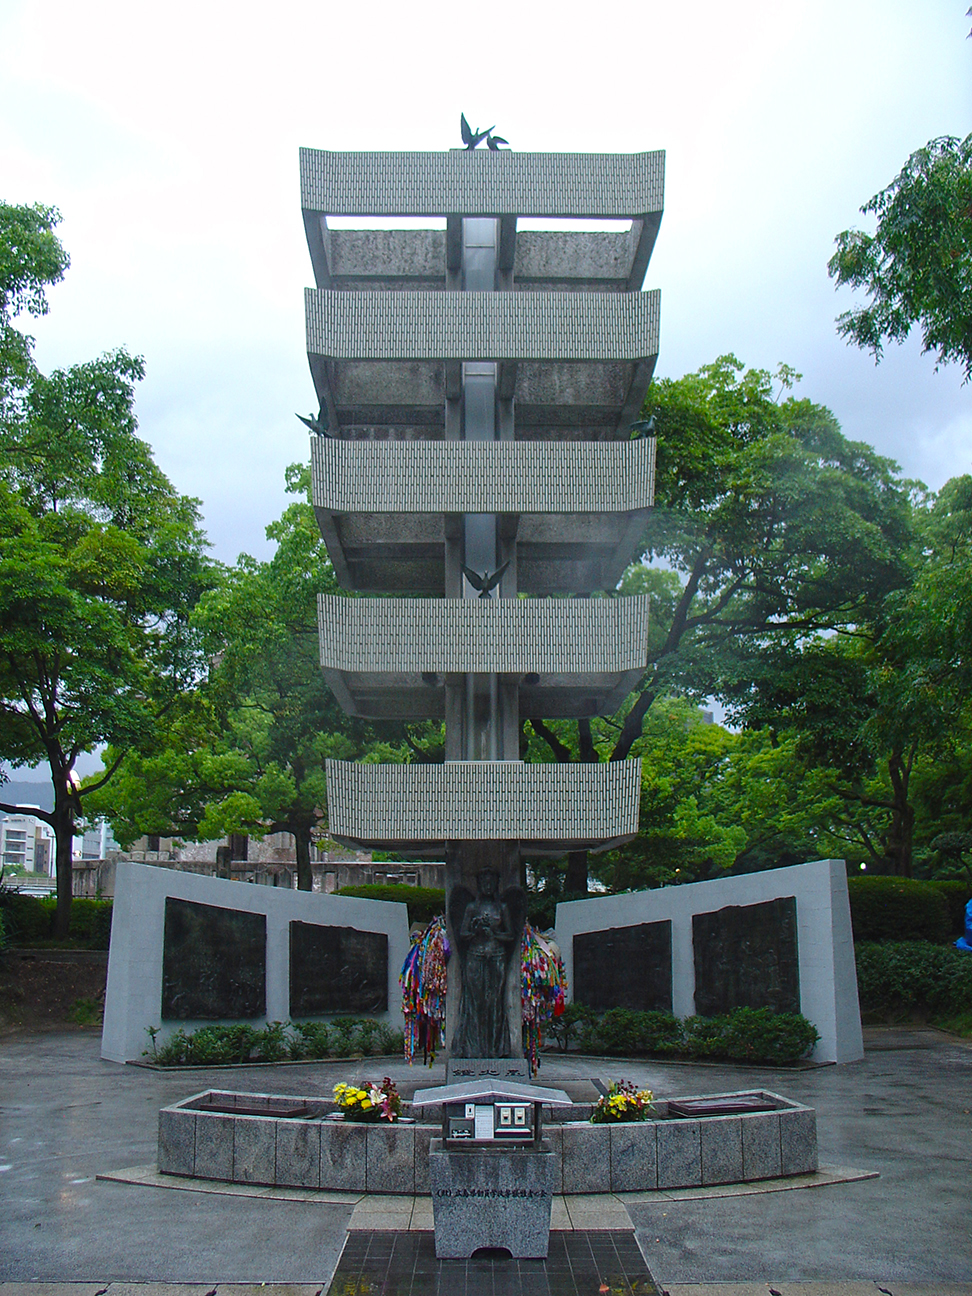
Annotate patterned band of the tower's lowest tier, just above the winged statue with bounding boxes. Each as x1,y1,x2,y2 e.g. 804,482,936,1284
327,758,642,842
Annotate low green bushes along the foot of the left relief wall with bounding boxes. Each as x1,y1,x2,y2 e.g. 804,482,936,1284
143,1017,404,1067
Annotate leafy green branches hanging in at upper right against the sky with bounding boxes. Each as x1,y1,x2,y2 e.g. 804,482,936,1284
827,135,972,381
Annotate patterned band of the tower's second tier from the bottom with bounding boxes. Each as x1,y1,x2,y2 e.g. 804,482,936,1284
318,595,649,675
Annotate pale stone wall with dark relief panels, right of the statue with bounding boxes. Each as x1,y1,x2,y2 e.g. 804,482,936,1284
556,859,863,1063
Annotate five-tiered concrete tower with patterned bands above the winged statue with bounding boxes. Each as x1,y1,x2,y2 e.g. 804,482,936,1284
301,149,665,1058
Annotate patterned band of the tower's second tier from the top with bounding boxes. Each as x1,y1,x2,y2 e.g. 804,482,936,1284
305,288,661,362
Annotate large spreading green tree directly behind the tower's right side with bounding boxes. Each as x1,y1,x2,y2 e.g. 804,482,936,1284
530,356,912,889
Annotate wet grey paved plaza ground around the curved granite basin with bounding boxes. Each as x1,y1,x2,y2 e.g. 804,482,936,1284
0,1029,972,1296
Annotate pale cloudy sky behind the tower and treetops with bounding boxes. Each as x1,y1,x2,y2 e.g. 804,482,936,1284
0,0,972,561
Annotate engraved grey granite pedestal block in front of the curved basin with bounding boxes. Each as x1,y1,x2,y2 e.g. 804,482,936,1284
429,1139,555,1260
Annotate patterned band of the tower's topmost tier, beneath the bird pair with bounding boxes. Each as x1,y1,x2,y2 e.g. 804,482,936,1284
301,149,665,219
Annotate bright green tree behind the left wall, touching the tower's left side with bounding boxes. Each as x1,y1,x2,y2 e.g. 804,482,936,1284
90,464,406,890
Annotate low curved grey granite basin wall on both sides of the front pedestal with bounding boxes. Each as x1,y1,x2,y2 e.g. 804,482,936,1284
158,1090,818,1194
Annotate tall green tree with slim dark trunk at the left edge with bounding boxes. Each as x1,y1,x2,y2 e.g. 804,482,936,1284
0,205,206,937
